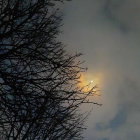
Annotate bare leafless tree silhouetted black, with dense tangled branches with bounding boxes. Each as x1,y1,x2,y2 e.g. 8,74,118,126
0,0,99,140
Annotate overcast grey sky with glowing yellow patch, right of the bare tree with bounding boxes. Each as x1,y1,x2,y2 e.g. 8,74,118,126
62,0,140,140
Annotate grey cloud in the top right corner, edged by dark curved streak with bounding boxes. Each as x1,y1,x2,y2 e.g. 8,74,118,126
103,0,140,29
